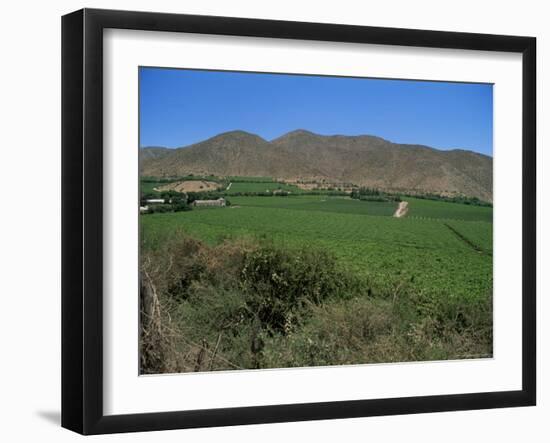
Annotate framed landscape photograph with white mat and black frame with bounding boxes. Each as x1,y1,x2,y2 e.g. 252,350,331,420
62,9,536,434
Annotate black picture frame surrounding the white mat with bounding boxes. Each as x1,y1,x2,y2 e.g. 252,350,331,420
62,9,536,434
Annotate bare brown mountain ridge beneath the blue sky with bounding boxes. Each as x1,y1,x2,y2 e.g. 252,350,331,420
140,130,493,201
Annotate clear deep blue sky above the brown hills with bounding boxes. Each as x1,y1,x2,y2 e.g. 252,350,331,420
139,67,493,155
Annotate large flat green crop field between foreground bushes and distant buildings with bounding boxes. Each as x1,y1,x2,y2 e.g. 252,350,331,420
141,196,492,299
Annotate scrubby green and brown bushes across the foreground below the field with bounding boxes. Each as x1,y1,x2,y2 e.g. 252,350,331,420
141,233,492,373
